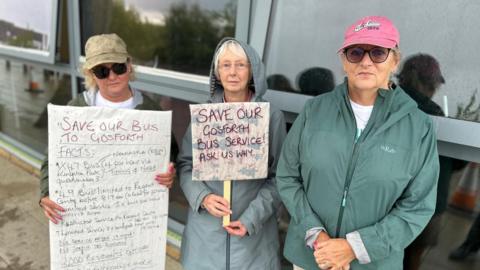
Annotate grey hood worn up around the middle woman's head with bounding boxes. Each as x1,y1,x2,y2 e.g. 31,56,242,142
210,37,267,103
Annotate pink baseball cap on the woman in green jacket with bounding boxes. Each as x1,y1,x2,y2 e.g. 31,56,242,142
338,16,400,52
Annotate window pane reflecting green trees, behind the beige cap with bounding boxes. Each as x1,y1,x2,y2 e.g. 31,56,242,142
80,0,237,75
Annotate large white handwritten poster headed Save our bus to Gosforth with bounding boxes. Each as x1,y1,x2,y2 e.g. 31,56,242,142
48,104,171,270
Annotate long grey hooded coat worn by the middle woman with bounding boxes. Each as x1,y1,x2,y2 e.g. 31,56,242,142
178,38,286,270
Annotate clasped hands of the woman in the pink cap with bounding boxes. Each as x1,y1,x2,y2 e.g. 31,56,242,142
313,231,355,270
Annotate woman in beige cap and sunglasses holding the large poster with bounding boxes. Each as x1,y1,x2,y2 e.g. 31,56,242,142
40,34,178,223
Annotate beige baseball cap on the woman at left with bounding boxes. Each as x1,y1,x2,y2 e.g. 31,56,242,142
83,34,129,69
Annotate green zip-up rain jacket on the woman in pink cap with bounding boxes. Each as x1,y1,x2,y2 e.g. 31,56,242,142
277,82,439,270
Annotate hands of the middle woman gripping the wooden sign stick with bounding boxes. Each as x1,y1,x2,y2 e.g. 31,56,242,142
202,193,247,237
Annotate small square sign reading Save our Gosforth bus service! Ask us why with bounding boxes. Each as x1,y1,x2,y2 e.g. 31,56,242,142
190,102,270,181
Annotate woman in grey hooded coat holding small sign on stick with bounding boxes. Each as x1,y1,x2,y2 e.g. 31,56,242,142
178,38,286,270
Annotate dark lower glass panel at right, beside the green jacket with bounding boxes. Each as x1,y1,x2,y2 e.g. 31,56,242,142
432,156,480,270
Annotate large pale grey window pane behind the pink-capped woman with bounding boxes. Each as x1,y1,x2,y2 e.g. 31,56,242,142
266,0,480,121
